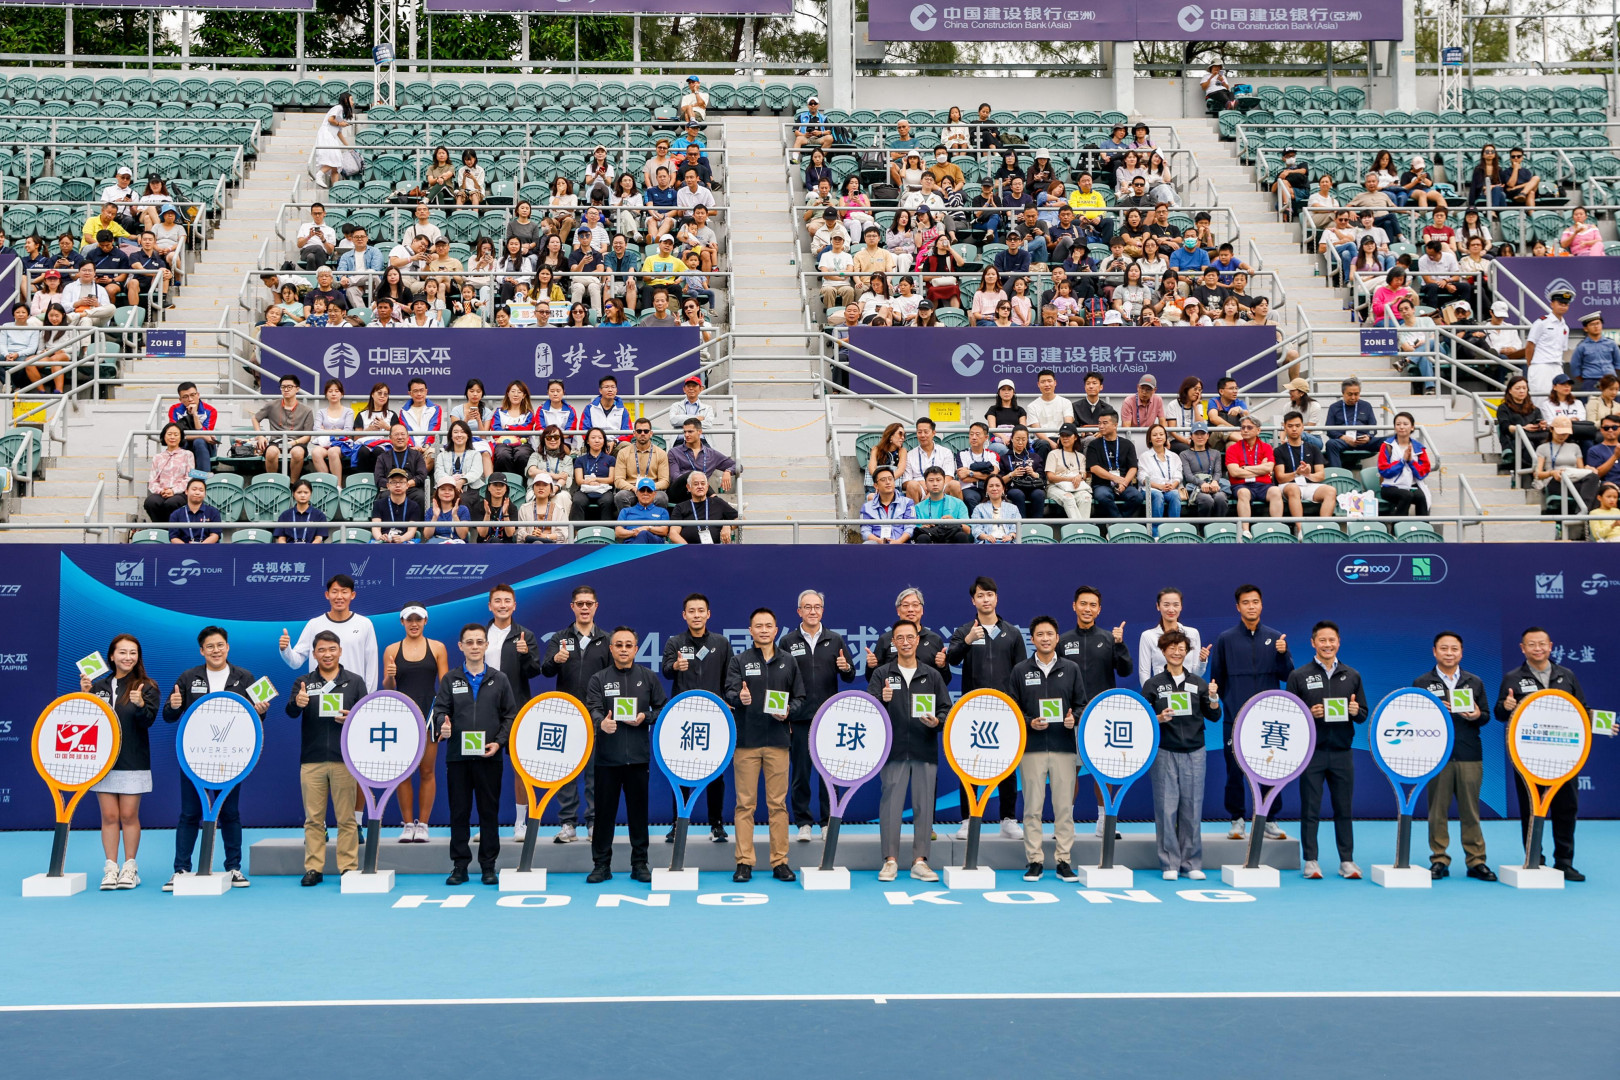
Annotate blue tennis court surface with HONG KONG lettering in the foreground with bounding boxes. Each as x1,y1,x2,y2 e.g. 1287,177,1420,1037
0,823,1620,1078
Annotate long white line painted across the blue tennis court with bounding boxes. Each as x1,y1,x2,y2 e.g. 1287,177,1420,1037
0,989,1620,1012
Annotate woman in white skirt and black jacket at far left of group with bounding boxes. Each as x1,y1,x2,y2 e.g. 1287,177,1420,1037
79,633,159,891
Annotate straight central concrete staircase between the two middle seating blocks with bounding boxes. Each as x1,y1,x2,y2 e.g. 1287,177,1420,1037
723,117,838,542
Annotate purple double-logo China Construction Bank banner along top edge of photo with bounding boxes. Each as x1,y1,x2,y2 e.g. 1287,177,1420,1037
868,0,1401,40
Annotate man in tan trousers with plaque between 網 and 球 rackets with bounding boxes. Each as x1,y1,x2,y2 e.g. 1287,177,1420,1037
726,607,805,881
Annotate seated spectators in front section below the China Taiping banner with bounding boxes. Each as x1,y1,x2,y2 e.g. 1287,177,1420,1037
144,374,742,544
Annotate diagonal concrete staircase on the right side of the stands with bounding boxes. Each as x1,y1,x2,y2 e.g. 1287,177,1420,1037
1149,118,1554,541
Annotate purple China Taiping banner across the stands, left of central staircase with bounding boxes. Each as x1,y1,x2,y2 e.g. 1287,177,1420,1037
259,327,703,398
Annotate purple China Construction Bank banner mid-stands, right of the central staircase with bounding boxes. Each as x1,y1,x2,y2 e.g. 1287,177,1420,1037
849,327,1277,398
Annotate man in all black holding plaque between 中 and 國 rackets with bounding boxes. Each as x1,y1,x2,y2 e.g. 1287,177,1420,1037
428,622,517,886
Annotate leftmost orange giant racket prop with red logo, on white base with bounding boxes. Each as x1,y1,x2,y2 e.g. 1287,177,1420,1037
23,693,123,897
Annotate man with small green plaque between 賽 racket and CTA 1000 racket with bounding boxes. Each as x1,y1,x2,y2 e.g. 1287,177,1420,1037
1286,619,1367,881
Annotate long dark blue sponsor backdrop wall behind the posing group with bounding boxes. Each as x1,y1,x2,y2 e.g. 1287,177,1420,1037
0,544,1620,829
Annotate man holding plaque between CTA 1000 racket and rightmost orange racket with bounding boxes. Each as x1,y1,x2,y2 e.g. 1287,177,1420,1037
1413,630,1497,881
